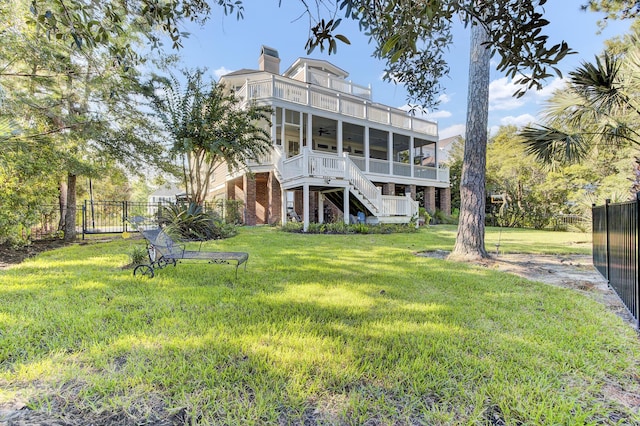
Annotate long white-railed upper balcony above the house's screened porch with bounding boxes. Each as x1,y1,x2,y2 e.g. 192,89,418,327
236,74,438,138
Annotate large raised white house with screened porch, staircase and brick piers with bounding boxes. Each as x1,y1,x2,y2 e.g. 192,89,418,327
213,46,451,229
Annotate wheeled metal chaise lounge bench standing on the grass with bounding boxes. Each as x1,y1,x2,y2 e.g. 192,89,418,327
130,218,249,278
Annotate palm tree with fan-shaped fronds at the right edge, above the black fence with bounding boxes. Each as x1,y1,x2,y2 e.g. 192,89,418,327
520,38,640,165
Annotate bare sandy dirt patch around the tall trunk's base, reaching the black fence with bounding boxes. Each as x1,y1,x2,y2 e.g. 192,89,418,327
417,250,635,327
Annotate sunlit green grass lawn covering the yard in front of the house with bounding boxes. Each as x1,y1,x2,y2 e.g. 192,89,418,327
0,226,640,425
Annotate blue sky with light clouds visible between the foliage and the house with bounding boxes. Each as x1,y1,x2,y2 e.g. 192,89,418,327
172,0,629,138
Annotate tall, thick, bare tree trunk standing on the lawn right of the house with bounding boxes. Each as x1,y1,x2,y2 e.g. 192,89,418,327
450,19,491,259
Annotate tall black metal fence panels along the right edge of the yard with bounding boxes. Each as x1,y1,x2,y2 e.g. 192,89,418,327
592,194,640,328
